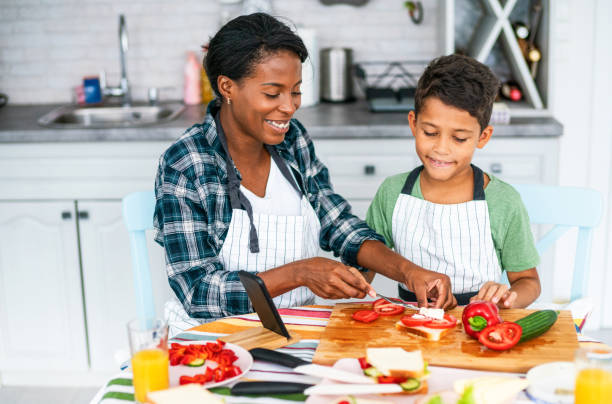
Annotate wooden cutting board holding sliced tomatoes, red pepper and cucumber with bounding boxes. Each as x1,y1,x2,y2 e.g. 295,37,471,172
313,303,578,373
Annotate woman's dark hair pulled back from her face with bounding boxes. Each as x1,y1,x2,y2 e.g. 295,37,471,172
203,13,308,98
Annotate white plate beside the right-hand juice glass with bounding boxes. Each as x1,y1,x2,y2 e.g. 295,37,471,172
527,362,576,404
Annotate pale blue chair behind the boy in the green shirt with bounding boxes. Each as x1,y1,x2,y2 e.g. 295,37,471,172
514,184,603,301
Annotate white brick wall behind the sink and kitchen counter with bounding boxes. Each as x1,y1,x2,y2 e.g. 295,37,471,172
0,0,440,104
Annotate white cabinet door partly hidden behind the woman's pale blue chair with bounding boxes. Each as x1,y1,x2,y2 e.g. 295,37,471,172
77,201,170,371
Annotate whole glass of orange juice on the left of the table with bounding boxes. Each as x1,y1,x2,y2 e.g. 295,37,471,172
128,319,169,403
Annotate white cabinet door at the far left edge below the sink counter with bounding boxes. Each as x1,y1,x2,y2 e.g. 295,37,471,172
0,201,87,371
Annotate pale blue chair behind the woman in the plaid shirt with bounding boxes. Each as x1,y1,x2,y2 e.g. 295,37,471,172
122,191,155,321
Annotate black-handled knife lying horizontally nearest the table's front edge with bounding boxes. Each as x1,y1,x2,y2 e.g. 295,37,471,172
230,382,403,396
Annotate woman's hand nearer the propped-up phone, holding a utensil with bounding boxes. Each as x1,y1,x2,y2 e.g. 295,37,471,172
295,257,376,299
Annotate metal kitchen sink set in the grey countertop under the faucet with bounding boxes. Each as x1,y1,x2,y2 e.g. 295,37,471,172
38,102,185,128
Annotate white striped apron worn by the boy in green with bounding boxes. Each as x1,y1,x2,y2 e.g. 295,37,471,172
391,166,502,304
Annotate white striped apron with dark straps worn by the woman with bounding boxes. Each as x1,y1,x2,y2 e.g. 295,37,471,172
164,112,321,336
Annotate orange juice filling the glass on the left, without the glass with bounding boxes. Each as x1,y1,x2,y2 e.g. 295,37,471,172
132,349,168,403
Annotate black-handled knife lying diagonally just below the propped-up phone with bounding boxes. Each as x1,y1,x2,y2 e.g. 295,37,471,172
249,348,375,384
